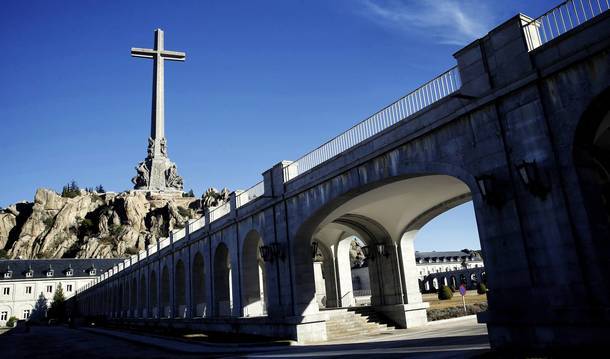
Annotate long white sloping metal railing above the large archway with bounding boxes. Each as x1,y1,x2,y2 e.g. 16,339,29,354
284,66,461,181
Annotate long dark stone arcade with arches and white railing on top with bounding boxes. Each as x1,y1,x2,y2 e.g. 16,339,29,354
78,4,610,354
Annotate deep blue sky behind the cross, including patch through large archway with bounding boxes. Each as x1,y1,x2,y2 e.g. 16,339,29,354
0,0,558,250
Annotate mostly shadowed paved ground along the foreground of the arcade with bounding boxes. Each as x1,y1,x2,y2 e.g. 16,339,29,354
0,317,489,359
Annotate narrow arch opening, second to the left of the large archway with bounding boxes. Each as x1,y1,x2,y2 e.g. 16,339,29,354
214,243,233,316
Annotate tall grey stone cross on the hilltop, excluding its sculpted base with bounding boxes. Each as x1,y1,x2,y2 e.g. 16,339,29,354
131,29,186,157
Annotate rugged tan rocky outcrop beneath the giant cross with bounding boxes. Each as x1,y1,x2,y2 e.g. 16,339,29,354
0,189,208,258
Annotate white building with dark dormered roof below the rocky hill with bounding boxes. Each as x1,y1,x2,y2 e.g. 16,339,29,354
0,259,123,326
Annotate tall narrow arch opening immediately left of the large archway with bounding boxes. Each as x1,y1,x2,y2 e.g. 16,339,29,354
241,230,267,317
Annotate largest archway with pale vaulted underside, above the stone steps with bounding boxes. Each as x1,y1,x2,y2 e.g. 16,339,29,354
291,168,481,313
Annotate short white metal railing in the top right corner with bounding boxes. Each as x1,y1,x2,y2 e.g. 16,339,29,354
523,0,610,51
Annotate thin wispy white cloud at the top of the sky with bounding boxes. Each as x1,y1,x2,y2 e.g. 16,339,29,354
361,0,499,45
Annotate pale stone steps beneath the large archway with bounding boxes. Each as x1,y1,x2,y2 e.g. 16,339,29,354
325,307,396,340
